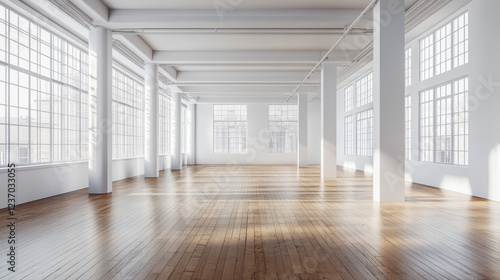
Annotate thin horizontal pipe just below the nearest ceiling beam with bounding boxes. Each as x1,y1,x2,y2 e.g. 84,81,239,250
113,28,373,35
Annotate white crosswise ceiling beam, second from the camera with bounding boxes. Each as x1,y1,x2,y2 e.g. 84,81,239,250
153,51,359,65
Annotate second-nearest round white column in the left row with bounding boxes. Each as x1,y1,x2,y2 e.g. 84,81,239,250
144,63,160,177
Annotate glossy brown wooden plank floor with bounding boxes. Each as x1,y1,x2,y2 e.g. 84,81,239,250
0,166,500,279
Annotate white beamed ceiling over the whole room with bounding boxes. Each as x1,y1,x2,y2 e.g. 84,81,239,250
64,0,446,102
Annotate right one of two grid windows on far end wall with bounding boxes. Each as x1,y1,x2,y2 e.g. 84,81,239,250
269,105,299,153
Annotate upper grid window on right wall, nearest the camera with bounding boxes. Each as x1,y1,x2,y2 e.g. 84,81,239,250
420,12,469,81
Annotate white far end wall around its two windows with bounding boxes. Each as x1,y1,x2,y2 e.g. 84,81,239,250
196,102,320,164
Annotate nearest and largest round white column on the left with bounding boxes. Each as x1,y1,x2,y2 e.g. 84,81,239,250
89,27,113,194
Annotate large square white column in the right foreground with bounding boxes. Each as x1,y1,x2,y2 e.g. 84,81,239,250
373,0,405,202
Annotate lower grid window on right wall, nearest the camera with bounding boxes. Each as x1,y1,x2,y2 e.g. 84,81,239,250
420,78,469,165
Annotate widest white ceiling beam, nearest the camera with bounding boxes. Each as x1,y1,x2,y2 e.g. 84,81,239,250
109,9,372,29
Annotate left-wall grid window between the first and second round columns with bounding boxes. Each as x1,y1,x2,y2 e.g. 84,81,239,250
112,68,144,158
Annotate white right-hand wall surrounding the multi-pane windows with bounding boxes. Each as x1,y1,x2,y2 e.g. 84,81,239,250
337,0,500,201
